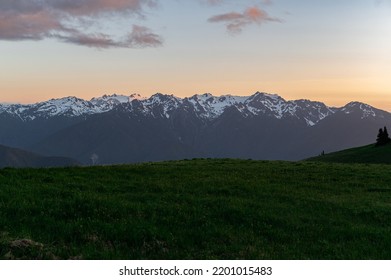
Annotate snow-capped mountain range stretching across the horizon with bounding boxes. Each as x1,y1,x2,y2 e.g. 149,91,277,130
0,92,391,164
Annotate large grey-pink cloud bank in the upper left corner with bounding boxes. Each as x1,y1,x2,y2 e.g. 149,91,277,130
0,0,162,48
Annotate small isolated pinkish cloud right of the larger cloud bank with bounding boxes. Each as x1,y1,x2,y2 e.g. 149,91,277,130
208,6,281,34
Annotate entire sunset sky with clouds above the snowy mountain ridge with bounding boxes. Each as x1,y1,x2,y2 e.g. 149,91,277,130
0,0,391,111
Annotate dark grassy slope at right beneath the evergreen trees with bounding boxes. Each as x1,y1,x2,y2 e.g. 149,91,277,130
307,144,391,164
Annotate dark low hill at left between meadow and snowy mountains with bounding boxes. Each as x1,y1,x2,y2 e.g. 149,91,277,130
0,145,79,168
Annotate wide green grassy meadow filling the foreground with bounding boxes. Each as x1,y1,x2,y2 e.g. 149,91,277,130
0,159,391,259
